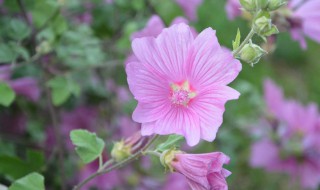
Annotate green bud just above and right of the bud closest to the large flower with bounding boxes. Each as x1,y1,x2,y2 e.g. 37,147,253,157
253,11,279,37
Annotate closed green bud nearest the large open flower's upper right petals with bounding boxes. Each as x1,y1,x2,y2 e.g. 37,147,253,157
240,41,267,66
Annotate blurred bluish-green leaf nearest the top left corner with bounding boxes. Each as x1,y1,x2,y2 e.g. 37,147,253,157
8,19,31,41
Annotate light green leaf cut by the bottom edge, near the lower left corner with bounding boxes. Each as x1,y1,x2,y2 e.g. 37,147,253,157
8,172,45,190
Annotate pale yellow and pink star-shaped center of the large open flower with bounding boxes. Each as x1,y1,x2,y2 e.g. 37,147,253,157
170,81,196,106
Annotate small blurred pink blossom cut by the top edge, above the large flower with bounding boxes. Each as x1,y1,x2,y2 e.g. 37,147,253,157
176,0,202,21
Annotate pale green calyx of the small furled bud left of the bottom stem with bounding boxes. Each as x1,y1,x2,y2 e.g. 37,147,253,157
111,141,131,162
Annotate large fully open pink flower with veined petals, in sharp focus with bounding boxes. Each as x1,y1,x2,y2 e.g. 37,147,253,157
126,24,241,146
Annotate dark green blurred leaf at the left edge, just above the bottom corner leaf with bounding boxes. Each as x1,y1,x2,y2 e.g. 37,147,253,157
0,150,44,180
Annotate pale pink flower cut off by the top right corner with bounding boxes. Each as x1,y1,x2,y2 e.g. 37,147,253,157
289,0,320,49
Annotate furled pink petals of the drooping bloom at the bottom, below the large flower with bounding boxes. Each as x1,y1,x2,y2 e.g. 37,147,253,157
171,152,231,190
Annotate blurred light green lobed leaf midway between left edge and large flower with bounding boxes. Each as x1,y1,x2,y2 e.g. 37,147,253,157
48,76,81,106
